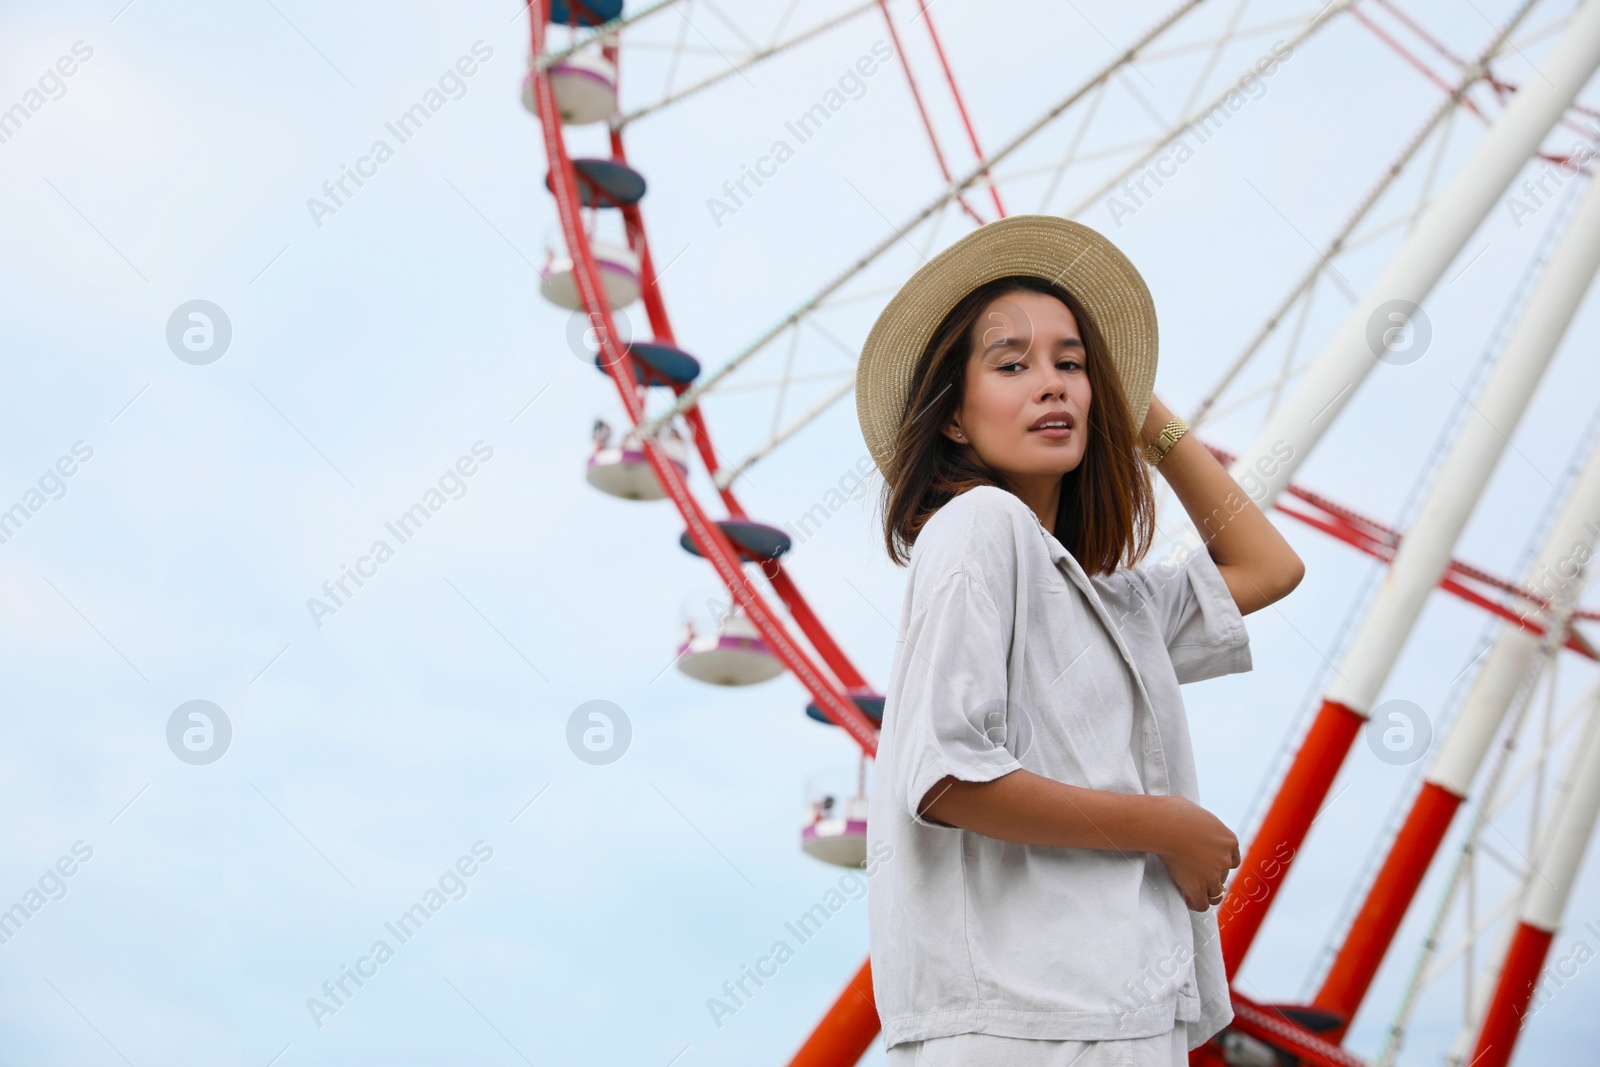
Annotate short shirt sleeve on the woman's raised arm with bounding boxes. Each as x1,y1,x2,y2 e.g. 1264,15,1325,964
1112,545,1251,683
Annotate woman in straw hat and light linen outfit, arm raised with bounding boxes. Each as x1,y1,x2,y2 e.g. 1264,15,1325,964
856,216,1304,1067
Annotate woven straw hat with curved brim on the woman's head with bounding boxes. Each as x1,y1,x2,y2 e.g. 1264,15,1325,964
856,214,1157,477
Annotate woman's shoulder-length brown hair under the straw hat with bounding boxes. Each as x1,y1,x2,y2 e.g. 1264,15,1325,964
880,275,1155,574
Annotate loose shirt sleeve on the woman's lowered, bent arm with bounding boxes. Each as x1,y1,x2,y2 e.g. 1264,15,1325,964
885,571,1022,829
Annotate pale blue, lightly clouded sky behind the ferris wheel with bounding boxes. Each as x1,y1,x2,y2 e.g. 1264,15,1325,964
0,0,1600,1067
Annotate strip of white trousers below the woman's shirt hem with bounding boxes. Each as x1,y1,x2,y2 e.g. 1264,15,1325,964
888,1022,1189,1067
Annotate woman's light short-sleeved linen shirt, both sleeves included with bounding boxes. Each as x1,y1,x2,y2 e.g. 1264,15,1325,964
867,486,1251,1048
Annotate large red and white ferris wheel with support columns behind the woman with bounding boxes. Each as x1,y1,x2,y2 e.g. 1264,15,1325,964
523,0,1600,1067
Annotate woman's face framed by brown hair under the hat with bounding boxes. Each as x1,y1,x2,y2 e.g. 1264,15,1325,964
944,291,1090,483
